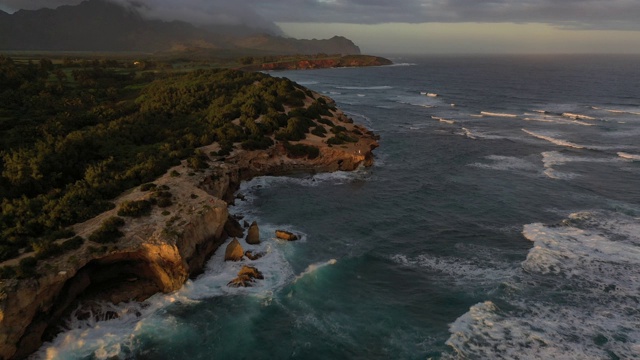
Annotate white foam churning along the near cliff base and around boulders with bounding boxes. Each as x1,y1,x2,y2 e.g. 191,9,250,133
32,228,302,359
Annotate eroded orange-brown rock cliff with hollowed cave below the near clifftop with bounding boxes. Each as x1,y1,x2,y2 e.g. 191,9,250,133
0,95,378,359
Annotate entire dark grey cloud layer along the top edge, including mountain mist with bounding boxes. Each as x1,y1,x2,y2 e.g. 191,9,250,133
0,0,640,30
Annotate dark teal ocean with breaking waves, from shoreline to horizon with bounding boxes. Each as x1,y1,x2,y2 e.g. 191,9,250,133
34,55,640,359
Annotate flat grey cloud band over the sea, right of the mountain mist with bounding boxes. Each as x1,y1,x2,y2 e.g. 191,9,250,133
246,0,640,29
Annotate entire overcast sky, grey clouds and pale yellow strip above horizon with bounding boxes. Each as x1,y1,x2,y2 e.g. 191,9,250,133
0,0,640,53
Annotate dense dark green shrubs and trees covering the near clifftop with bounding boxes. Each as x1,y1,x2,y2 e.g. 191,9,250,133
0,55,335,264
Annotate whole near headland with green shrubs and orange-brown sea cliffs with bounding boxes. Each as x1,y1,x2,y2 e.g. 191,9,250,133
0,58,378,359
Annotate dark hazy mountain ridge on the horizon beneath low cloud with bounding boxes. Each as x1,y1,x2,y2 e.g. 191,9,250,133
0,0,360,55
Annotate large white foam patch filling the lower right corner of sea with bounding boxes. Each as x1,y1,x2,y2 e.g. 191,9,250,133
445,211,640,359
